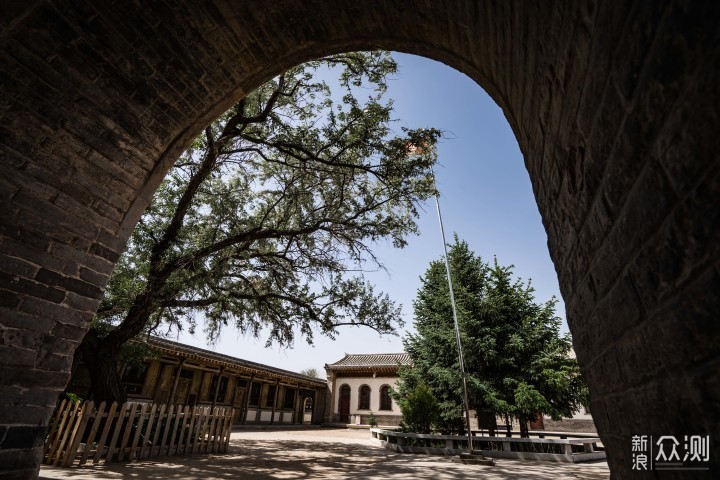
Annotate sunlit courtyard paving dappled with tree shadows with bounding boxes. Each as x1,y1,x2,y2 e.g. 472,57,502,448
40,428,610,480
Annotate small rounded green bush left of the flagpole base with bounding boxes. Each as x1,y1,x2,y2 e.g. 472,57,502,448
392,380,440,433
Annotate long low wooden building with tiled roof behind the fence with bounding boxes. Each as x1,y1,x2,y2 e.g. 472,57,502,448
67,337,327,424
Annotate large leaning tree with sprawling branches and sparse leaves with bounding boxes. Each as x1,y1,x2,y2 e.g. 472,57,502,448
81,52,440,401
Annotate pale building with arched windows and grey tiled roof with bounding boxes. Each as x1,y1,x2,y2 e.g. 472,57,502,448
325,353,410,426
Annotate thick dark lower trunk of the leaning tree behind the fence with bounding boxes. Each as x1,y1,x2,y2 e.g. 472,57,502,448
79,330,127,404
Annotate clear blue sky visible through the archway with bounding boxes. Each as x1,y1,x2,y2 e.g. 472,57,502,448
177,54,567,375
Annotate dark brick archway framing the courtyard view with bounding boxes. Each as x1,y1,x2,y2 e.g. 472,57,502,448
0,0,720,478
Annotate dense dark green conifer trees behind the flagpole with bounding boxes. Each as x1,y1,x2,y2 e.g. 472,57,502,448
396,237,587,434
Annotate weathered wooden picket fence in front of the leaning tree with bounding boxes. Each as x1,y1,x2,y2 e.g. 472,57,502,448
43,400,233,467
